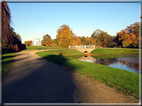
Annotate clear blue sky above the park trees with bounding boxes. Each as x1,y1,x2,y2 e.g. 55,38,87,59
8,2,140,43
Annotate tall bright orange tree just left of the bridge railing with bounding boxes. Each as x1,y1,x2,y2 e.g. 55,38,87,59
57,26,72,48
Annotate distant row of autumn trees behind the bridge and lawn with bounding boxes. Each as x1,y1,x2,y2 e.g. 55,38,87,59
25,22,141,48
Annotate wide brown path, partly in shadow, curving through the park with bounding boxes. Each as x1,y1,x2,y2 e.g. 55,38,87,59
2,50,139,103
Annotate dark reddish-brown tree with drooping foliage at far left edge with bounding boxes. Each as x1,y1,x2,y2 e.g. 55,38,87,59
2,2,22,53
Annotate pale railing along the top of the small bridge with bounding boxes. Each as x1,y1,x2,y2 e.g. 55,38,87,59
69,45,95,49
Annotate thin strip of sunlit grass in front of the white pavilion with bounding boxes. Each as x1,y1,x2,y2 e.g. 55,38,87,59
26,46,61,50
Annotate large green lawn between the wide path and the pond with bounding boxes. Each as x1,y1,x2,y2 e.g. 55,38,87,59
36,50,139,99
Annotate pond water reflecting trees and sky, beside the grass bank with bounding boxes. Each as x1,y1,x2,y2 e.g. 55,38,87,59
79,55,139,73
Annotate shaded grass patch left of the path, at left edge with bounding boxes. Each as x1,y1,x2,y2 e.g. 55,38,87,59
2,53,14,77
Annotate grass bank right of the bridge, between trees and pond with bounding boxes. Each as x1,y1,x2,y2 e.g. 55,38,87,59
91,48,139,55
